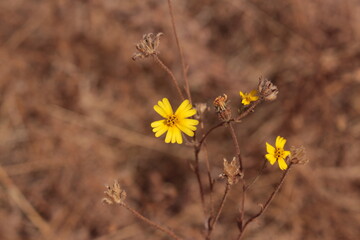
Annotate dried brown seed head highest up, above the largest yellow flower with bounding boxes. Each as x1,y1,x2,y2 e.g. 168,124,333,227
132,33,163,61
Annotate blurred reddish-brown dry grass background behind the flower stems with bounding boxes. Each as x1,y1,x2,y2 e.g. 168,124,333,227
0,0,360,240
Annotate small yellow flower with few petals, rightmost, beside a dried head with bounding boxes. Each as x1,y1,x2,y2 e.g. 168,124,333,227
265,136,290,170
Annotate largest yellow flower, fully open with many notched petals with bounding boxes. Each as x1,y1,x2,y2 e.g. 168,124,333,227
151,98,199,144
